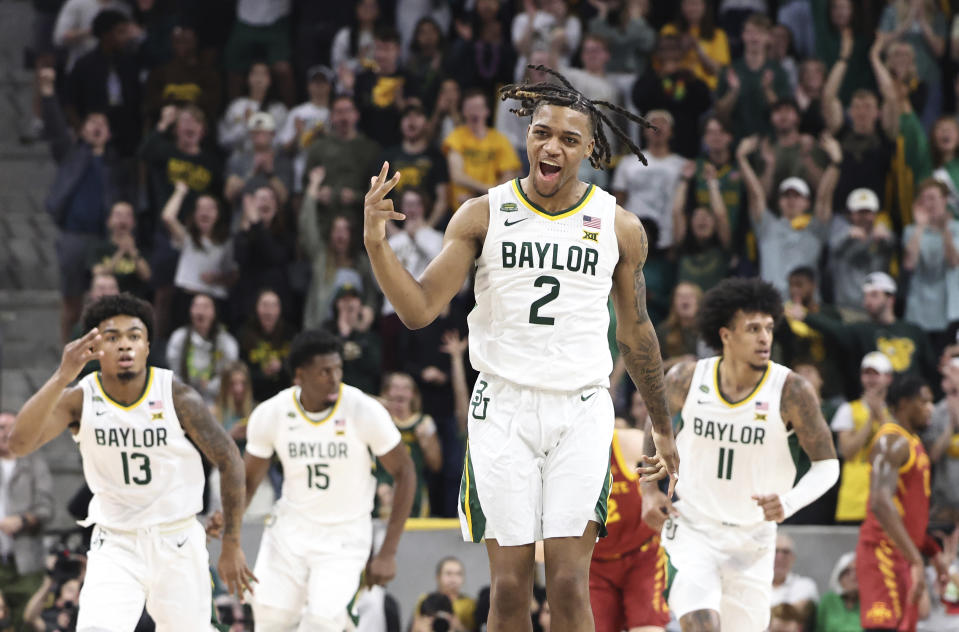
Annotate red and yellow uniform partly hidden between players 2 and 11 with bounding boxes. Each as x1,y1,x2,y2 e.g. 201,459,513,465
589,432,669,632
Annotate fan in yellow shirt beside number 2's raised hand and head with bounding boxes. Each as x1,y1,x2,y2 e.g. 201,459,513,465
443,90,522,210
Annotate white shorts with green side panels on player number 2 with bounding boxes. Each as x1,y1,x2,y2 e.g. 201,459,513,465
459,373,613,546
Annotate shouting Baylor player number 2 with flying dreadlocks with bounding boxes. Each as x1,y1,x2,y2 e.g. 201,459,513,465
364,67,678,632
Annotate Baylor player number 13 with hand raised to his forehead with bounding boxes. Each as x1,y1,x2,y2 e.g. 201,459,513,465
10,294,253,632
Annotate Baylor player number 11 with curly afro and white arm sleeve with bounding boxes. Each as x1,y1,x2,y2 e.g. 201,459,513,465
642,279,839,632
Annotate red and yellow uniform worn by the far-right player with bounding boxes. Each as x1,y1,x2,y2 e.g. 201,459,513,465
856,423,935,632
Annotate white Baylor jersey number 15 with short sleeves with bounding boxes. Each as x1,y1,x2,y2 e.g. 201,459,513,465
246,384,400,524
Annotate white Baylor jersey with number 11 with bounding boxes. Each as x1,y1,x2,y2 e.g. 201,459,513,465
676,357,798,526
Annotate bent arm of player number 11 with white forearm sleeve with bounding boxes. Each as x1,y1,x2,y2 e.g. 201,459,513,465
753,373,839,522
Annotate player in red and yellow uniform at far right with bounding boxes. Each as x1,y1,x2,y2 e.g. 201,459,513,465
856,376,948,632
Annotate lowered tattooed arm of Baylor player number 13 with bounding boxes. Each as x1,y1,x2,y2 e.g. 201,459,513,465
173,381,256,595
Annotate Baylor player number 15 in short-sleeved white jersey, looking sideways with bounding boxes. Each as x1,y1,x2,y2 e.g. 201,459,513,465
244,330,416,632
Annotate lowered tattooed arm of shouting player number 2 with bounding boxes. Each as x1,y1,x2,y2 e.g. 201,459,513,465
612,207,679,496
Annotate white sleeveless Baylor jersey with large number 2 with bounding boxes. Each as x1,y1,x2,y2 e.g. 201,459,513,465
469,179,619,391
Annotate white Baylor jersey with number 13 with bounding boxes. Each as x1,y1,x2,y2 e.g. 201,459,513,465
76,367,204,529
